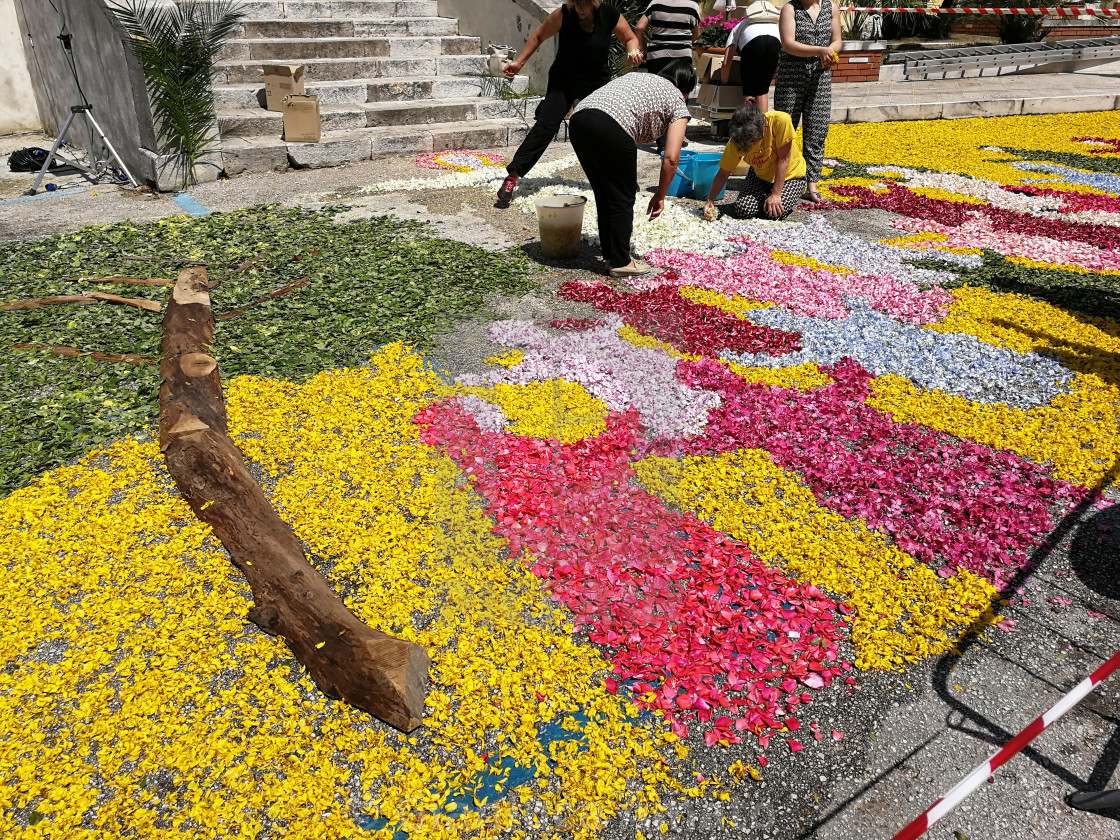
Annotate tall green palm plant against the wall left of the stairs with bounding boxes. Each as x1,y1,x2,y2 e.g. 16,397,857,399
109,0,245,188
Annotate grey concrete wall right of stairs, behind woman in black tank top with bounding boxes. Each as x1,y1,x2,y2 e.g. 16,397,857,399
439,0,561,93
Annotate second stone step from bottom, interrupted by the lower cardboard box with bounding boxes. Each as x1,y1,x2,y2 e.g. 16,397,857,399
217,96,517,138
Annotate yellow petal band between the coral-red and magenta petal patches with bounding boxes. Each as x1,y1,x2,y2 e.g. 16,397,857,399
635,449,997,669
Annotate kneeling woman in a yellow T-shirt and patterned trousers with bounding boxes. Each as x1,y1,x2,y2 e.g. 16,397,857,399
703,102,805,220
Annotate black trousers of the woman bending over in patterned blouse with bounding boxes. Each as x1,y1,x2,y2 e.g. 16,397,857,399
568,109,638,269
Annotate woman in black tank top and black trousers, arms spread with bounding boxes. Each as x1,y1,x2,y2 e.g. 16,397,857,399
497,0,642,207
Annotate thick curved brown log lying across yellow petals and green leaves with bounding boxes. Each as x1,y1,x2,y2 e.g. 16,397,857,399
159,268,430,731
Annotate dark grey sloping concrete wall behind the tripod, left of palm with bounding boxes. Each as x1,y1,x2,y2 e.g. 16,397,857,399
15,0,156,178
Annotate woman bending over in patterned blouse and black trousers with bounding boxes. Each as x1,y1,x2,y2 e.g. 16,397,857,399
569,60,694,277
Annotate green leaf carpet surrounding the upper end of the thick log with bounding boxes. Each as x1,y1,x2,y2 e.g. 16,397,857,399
0,207,532,495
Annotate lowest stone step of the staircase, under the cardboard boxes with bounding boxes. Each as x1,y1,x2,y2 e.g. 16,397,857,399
222,120,529,176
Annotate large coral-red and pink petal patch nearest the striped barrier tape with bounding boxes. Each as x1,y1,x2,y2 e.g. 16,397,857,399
417,401,849,746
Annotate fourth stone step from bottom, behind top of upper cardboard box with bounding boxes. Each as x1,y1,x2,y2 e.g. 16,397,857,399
213,55,489,86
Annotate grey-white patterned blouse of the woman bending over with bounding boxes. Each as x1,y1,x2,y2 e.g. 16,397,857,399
572,73,691,146
